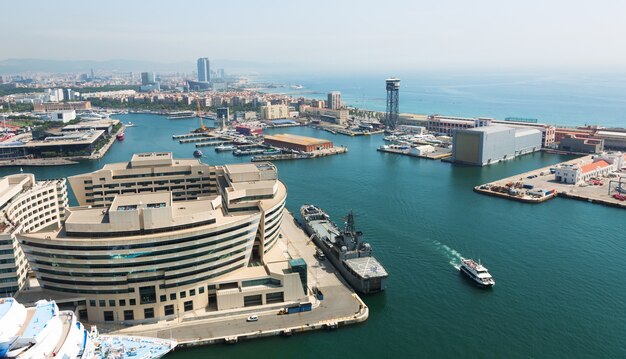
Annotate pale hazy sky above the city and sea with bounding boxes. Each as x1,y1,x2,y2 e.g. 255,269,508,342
0,0,626,71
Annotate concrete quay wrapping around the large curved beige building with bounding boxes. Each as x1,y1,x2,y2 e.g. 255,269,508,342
105,210,369,347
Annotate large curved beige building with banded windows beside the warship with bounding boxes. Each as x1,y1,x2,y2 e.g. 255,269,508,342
16,153,308,324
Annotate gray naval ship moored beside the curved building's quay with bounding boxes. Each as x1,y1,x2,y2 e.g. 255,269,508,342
300,204,389,294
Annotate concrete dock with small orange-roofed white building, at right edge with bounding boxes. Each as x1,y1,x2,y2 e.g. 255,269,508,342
473,155,626,208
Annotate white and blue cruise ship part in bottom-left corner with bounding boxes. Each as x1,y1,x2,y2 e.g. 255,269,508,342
0,298,178,359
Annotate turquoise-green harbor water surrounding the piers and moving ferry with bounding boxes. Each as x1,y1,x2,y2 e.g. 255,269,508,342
0,115,626,359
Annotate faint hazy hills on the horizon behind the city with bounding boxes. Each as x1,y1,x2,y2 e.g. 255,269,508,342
0,59,286,74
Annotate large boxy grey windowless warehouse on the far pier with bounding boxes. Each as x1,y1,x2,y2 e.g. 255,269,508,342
452,126,541,166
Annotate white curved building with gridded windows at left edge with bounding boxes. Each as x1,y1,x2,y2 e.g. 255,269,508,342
0,173,67,297
